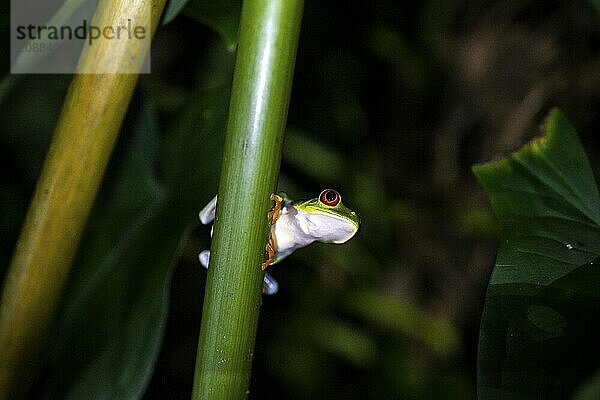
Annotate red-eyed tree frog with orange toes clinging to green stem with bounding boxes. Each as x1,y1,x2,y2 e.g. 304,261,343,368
198,189,360,294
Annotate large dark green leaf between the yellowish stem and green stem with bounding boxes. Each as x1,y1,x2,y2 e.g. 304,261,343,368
35,80,228,399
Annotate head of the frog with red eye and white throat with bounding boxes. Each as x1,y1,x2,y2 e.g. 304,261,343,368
293,189,360,243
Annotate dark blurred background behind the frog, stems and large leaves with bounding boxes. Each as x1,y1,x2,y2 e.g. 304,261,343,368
0,0,600,399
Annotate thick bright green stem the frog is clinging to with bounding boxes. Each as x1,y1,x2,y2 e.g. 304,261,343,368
192,0,303,400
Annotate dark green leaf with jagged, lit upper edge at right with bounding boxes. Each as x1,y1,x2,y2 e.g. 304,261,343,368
473,110,600,399
